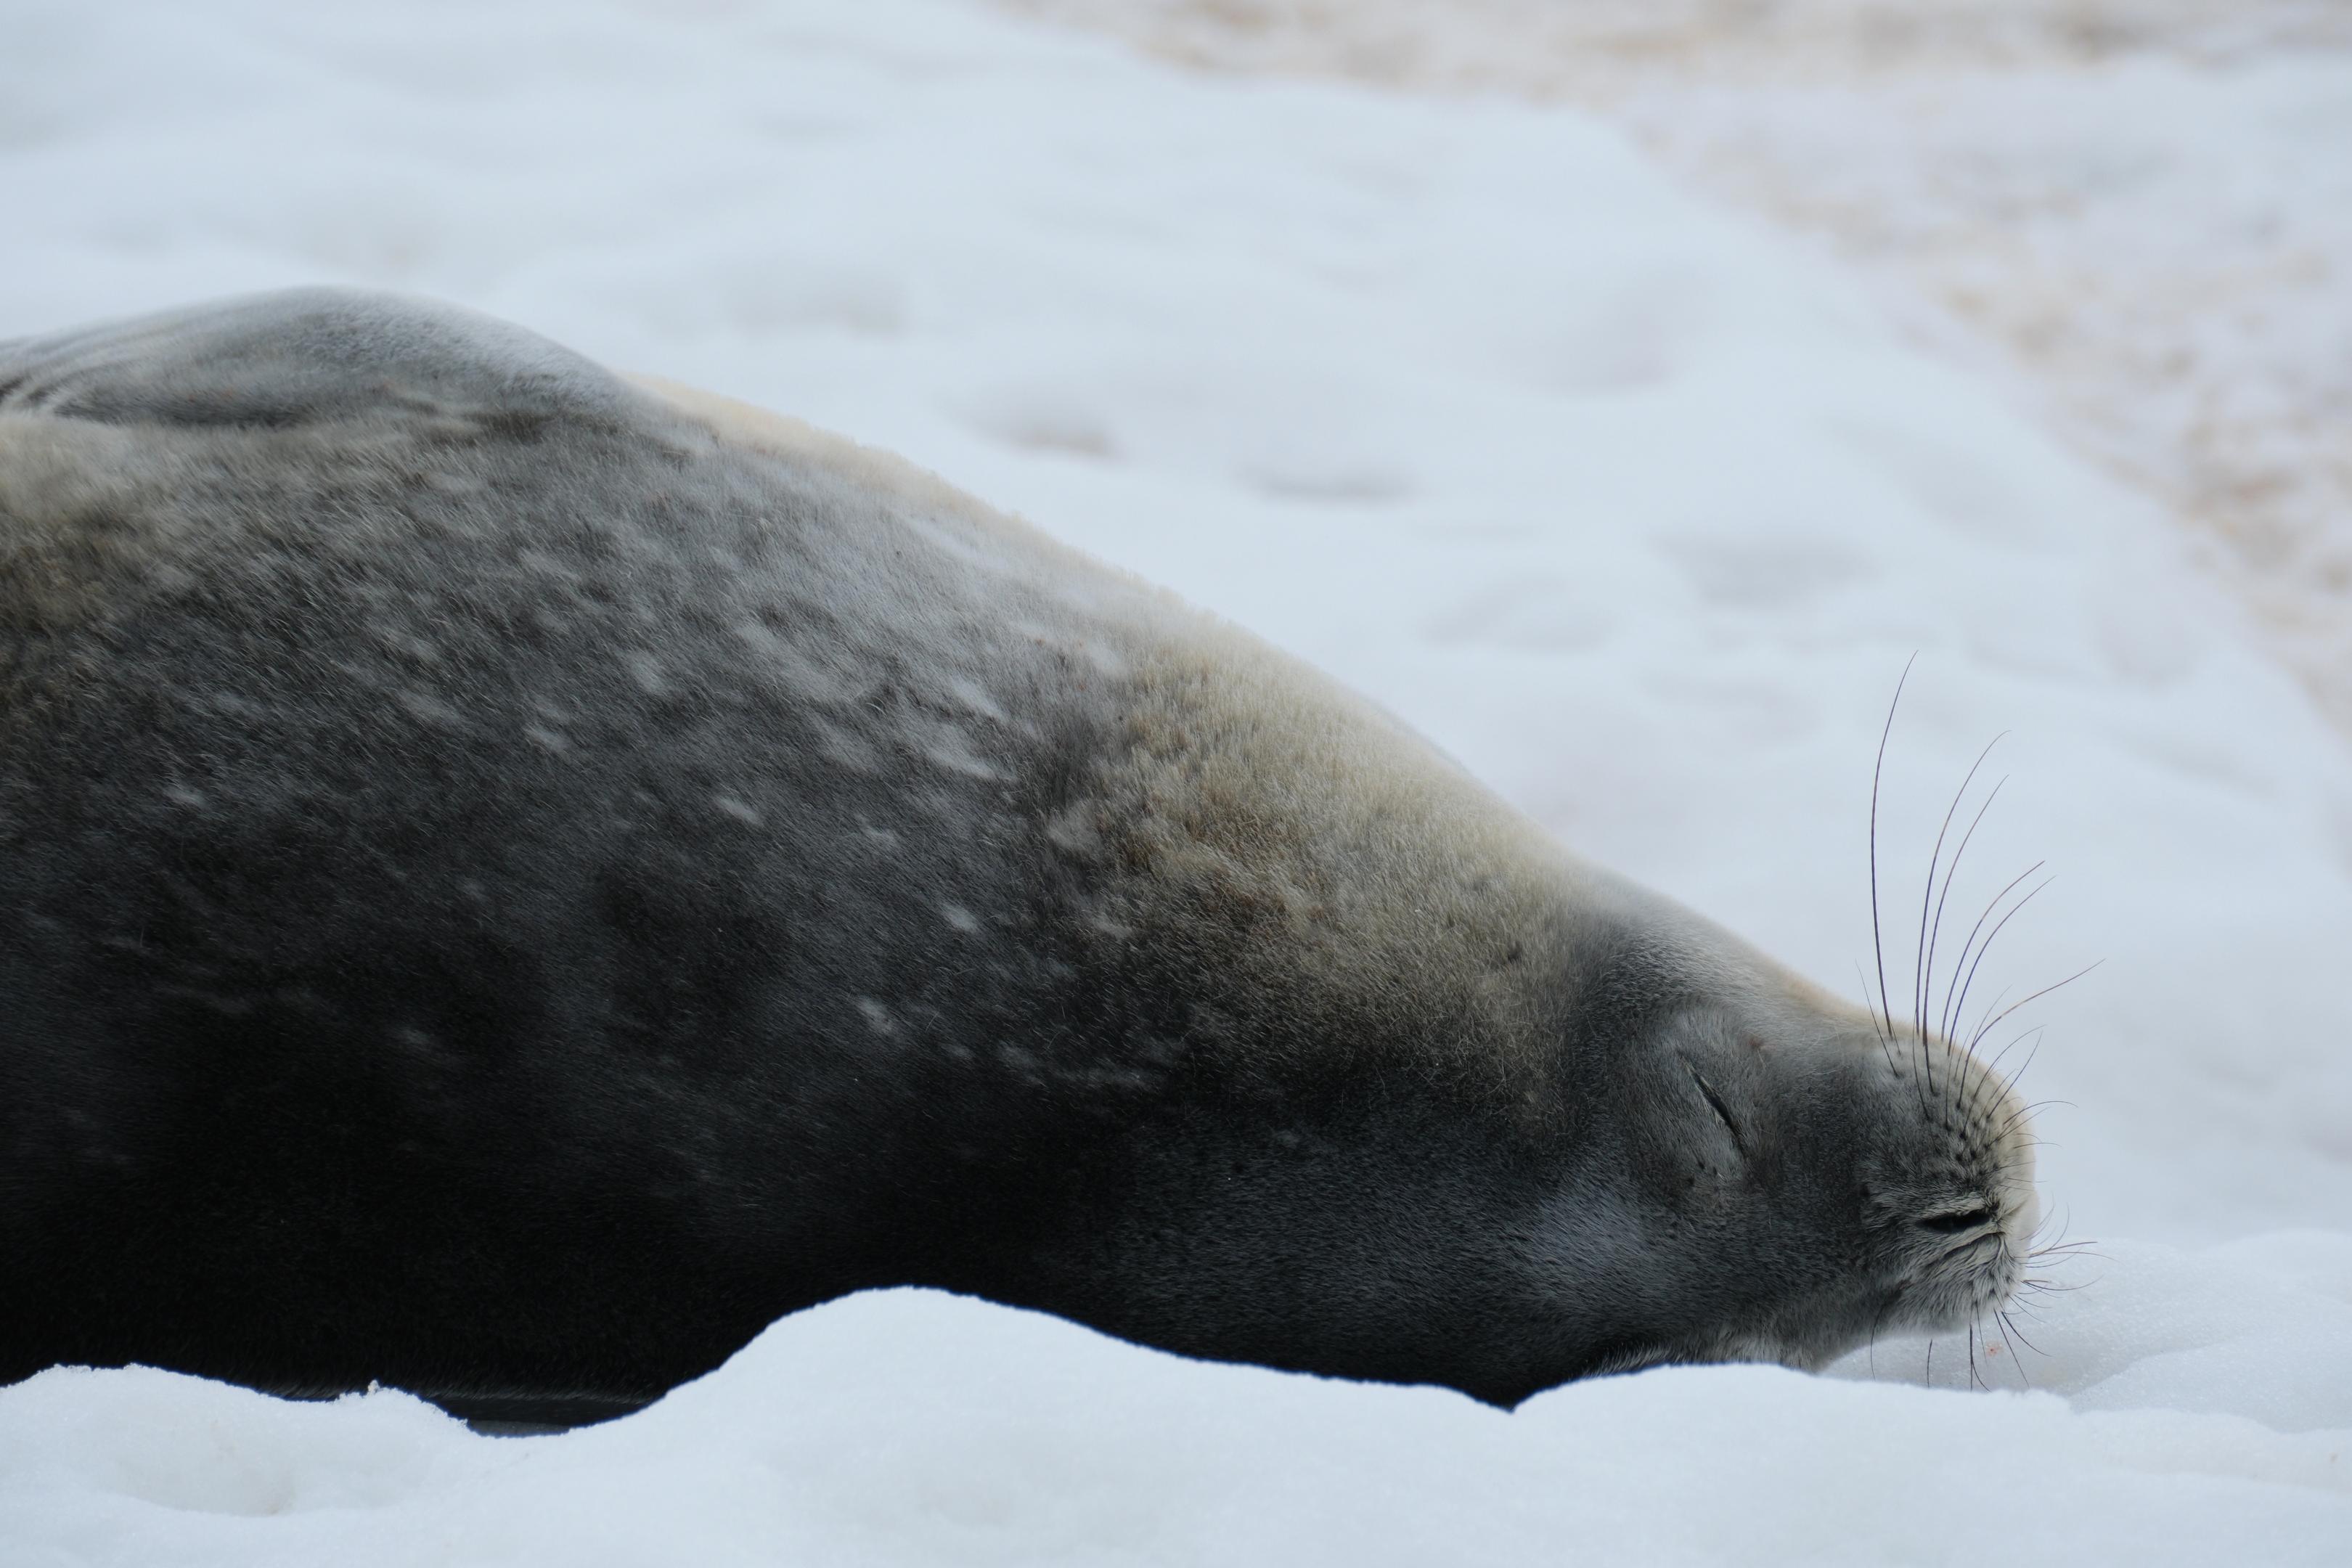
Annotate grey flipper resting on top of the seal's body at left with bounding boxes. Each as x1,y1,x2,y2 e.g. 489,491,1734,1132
0,289,645,430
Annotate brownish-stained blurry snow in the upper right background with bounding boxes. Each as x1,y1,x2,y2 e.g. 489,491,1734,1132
1002,0,2352,733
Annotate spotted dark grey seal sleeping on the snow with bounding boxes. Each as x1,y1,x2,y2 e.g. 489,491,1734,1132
0,292,2035,1418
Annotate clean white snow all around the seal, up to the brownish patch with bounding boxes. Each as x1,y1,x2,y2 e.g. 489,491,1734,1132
0,0,2352,1568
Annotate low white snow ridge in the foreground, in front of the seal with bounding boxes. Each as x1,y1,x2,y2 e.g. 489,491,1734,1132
14,1239,2352,1568
